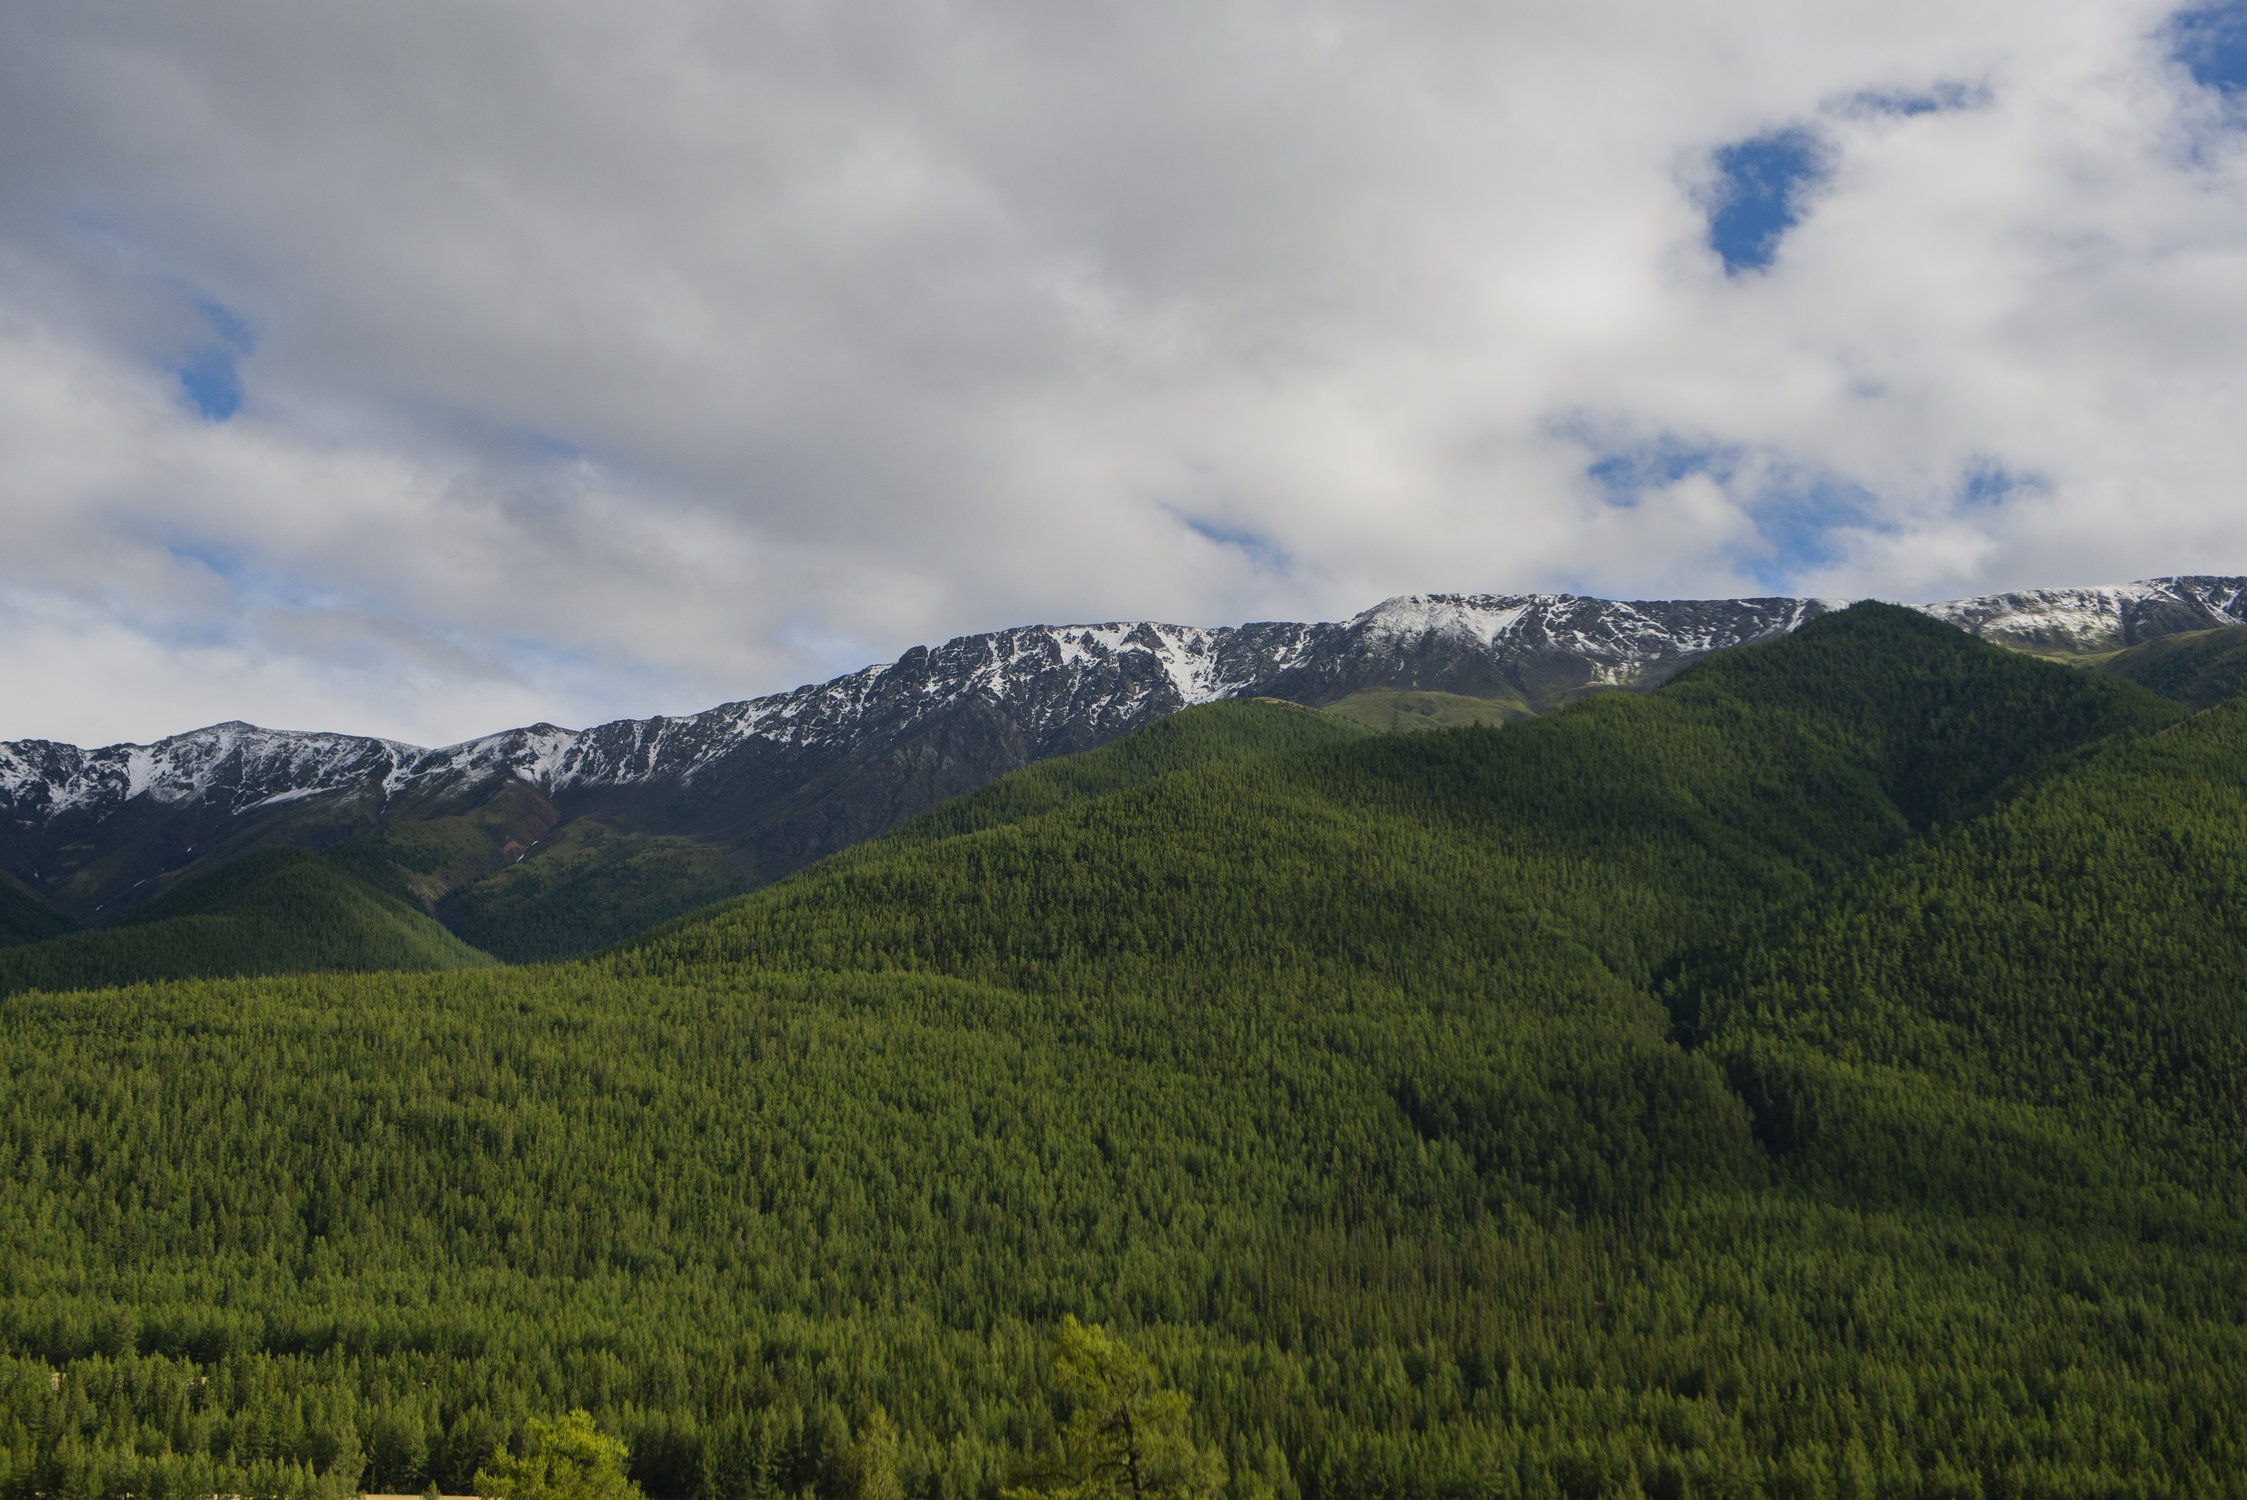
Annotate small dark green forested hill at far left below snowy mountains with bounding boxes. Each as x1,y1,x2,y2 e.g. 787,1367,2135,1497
0,849,492,995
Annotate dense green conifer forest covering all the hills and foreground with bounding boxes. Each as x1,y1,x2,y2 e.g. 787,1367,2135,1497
0,606,2247,1500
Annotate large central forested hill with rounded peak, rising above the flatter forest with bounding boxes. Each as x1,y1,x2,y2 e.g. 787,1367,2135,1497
622,604,2184,997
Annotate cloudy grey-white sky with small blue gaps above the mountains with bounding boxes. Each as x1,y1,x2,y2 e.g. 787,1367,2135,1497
0,0,2247,743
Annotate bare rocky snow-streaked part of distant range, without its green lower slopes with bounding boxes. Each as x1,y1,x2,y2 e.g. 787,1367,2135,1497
0,577,2247,914
